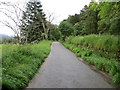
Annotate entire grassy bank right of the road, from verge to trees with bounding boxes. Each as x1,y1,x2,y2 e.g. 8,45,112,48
62,35,120,84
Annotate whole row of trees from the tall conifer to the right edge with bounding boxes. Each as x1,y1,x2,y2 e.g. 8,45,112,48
1,0,120,43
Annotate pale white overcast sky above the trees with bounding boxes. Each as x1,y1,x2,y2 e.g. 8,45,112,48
0,0,91,36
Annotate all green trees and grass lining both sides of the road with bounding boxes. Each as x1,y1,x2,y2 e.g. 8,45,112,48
0,0,120,89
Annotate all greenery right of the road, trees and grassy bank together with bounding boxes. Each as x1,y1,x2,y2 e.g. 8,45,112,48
58,2,120,84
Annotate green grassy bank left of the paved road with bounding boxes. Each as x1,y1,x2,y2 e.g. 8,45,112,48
2,41,51,89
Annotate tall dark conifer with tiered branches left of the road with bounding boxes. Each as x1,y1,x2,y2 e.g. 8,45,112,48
21,0,48,43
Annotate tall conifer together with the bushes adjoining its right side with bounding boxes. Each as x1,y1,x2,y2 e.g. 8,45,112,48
20,0,59,43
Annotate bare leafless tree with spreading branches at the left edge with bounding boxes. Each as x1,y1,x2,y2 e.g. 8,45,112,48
0,2,24,43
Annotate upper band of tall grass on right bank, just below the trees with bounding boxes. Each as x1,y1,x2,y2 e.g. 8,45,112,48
66,34,120,52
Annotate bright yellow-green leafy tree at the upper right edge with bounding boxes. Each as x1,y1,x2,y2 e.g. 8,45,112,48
98,2,120,35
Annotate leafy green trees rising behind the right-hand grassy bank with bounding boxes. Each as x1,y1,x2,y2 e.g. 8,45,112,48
59,2,120,39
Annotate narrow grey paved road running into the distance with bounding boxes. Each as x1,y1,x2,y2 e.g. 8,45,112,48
27,42,112,88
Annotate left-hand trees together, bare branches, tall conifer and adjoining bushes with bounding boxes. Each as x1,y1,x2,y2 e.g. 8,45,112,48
3,0,58,44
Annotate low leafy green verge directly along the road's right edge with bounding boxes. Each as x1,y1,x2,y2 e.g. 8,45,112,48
62,42,120,84
